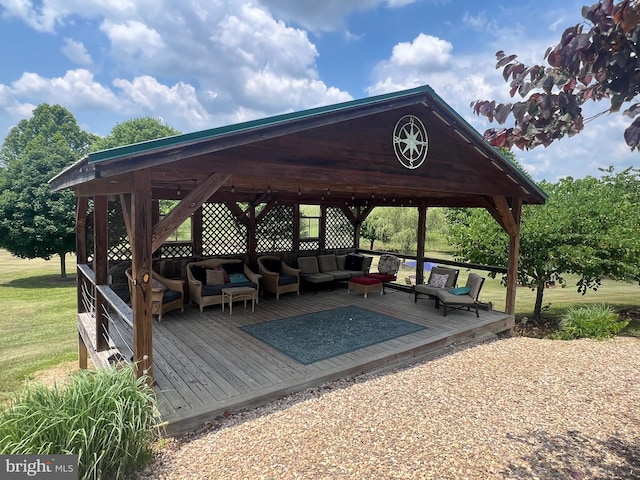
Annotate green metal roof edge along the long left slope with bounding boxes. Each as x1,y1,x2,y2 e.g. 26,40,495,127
88,85,436,163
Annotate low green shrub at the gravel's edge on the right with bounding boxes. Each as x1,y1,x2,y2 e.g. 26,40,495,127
555,305,629,340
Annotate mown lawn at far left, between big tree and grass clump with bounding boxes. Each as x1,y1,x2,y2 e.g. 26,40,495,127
0,250,78,402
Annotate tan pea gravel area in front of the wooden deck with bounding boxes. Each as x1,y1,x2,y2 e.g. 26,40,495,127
132,337,640,480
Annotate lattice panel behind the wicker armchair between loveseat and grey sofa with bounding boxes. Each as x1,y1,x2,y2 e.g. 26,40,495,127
256,205,294,253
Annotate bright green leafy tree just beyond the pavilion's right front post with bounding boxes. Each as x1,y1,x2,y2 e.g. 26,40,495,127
449,168,640,319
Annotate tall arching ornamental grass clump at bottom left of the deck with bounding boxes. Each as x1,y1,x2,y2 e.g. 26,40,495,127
0,366,159,479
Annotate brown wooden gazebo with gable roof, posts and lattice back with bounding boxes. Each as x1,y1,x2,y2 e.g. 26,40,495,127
50,86,545,386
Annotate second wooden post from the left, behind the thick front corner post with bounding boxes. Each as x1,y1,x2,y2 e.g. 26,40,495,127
93,195,109,352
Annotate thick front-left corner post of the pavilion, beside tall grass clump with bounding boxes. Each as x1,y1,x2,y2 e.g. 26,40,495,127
129,170,153,378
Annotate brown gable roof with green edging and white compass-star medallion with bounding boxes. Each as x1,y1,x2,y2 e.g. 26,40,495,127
50,86,546,206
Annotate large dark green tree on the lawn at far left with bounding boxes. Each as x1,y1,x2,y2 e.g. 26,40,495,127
0,104,96,278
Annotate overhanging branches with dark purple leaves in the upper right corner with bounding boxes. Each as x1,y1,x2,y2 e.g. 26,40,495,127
472,0,640,150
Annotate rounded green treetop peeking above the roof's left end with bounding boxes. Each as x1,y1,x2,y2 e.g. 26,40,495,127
91,117,180,152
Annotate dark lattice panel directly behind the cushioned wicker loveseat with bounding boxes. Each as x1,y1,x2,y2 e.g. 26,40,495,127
202,203,248,256
